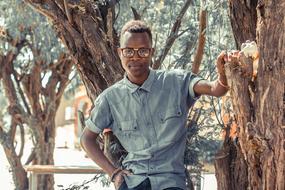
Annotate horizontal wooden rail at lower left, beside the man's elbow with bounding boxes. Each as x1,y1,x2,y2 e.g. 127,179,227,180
24,165,105,174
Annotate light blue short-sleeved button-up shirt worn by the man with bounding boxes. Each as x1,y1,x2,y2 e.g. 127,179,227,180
86,70,202,190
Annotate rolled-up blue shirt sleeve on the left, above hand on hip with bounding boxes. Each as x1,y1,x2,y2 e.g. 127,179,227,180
85,96,113,133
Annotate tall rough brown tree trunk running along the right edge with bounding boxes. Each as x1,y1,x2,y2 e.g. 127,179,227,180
251,0,285,190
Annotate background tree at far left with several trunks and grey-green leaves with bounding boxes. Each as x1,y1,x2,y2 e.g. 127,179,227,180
0,1,73,189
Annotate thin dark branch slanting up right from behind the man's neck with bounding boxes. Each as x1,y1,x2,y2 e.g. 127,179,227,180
152,0,191,69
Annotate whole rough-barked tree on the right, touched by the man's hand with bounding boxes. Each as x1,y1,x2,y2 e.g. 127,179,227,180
216,0,285,190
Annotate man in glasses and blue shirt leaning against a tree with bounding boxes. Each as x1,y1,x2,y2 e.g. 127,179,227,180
81,21,228,190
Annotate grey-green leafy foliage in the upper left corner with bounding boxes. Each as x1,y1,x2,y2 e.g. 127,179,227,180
0,0,65,65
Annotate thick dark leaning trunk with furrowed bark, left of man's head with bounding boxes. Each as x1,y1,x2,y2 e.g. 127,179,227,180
26,0,124,101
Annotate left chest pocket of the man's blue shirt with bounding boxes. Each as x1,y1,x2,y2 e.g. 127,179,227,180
115,120,146,152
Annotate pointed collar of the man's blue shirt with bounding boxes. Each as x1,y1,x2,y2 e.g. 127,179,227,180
124,68,155,93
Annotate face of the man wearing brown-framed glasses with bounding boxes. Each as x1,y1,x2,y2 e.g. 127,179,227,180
118,32,153,83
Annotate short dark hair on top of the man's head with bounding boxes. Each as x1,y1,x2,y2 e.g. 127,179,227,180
120,20,152,44
